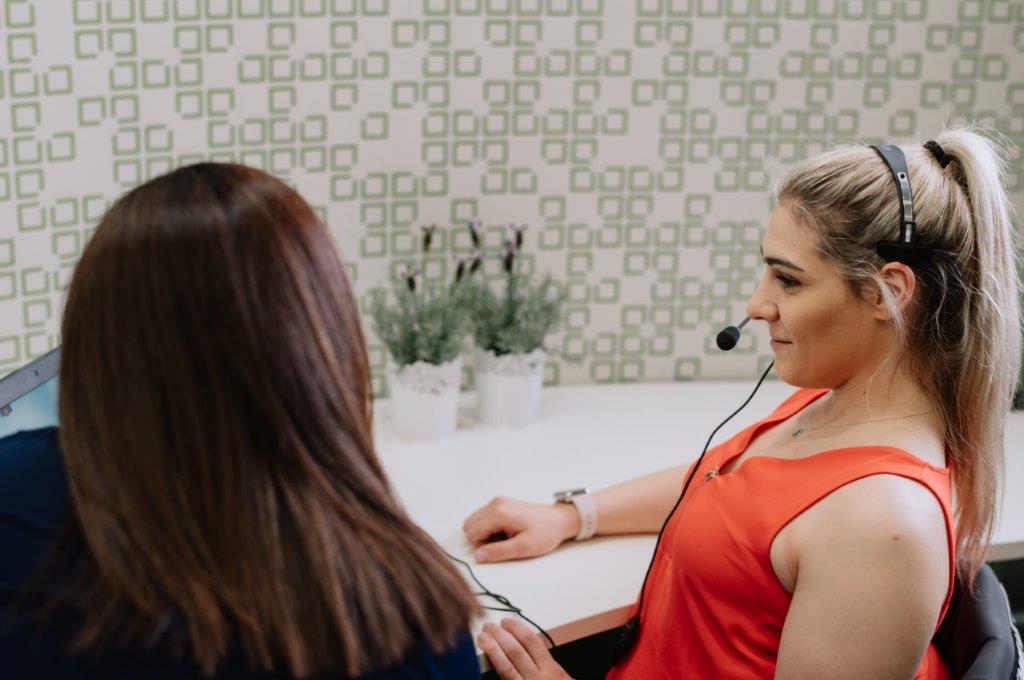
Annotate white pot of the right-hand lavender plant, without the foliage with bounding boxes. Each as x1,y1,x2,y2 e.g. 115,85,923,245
475,348,547,427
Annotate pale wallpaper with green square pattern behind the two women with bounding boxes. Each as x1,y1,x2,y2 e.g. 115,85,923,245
0,0,1024,391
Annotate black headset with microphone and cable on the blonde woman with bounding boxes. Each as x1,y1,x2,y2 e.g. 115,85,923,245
614,141,937,664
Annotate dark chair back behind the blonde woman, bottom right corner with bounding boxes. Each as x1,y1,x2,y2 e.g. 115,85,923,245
932,564,1024,680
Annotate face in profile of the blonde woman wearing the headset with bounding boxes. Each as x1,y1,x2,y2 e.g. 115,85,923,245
746,204,886,387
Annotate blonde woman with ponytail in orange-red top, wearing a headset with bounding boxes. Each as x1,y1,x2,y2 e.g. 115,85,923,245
464,127,1021,680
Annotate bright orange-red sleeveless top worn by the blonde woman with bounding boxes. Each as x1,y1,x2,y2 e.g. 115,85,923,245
607,389,956,680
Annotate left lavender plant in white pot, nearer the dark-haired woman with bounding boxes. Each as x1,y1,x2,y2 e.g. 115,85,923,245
370,225,479,440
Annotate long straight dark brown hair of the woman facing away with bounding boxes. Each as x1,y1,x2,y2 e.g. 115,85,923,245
48,163,477,677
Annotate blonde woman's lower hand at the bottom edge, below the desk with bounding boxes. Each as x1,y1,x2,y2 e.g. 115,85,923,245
476,619,571,680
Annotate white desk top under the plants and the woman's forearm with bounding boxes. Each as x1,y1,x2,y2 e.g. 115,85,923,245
376,380,1024,659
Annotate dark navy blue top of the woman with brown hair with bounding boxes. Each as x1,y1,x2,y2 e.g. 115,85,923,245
0,427,480,680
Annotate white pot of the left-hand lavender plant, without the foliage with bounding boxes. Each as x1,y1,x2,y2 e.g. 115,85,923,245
388,356,462,441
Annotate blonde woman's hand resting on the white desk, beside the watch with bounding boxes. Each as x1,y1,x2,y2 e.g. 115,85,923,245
462,498,580,562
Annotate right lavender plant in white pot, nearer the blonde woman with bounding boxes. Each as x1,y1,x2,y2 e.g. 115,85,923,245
463,221,562,427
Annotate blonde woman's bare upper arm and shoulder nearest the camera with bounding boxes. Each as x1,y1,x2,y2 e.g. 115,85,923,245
775,475,949,680
